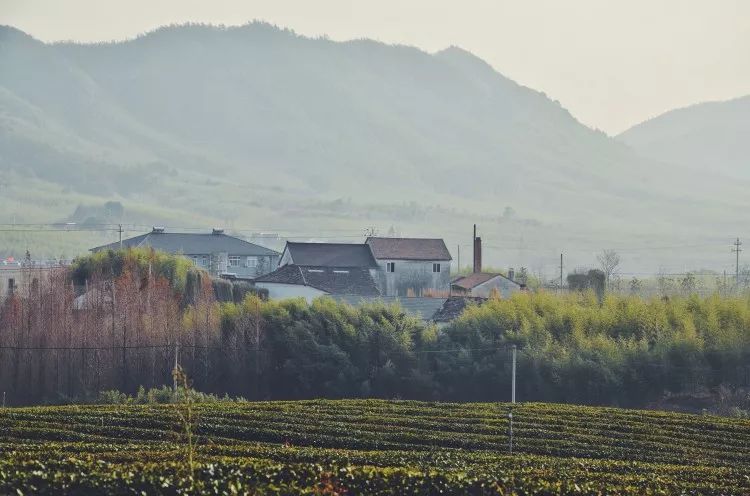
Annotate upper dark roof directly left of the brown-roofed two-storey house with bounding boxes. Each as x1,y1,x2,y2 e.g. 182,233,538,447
285,241,377,268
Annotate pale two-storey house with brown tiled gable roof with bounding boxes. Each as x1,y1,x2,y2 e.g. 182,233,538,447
365,238,453,297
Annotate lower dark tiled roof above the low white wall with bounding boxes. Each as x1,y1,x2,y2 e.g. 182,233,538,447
255,264,380,296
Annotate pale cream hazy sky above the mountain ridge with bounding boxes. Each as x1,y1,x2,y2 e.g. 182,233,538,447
0,0,750,134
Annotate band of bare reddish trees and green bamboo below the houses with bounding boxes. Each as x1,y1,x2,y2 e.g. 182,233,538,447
0,251,750,406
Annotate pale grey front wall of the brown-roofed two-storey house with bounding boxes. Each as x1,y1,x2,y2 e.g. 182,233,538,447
371,259,451,296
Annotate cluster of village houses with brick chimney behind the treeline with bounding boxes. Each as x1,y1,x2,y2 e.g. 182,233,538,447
76,227,525,323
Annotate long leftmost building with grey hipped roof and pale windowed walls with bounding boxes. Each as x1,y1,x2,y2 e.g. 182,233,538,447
91,227,279,279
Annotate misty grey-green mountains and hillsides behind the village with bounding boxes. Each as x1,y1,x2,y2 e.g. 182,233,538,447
0,23,750,273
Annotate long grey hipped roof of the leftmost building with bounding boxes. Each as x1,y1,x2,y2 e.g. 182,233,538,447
91,232,279,256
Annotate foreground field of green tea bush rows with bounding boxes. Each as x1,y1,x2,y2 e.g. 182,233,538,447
0,400,750,495
